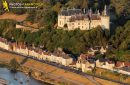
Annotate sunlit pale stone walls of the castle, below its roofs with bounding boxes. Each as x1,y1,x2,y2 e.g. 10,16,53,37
58,15,107,30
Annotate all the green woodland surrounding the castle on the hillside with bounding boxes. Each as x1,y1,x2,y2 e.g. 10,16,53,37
0,0,130,61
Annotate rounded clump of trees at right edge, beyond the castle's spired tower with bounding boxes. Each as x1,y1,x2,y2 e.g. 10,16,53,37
111,21,130,50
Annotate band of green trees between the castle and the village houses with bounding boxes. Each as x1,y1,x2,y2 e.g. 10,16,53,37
1,20,109,54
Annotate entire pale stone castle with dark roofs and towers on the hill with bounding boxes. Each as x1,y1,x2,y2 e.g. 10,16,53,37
58,6,110,30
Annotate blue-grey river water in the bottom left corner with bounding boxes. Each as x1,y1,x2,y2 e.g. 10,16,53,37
0,68,47,85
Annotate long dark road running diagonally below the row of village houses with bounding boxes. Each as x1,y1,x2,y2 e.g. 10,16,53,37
0,48,129,85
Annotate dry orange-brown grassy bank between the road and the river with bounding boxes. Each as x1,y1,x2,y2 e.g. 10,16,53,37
0,51,120,85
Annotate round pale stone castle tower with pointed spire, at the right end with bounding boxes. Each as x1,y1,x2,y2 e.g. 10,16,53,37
101,5,110,30
